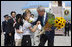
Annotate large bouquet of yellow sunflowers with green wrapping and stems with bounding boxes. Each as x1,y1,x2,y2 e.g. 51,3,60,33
40,13,66,35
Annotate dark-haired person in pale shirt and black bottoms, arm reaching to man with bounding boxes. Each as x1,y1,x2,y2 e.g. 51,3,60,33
22,13,38,46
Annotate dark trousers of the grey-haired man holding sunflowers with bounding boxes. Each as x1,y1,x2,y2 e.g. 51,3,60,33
39,34,54,46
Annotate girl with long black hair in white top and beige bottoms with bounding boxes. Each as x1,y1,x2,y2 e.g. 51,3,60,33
15,14,23,46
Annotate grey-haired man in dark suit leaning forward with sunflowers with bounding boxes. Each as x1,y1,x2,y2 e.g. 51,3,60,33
32,6,55,46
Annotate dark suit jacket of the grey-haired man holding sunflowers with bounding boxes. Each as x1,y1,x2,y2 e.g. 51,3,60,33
32,13,56,36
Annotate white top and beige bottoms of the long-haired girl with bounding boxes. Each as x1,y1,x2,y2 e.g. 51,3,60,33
15,25,22,46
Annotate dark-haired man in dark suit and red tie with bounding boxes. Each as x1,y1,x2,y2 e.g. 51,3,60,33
8,11,16,46
